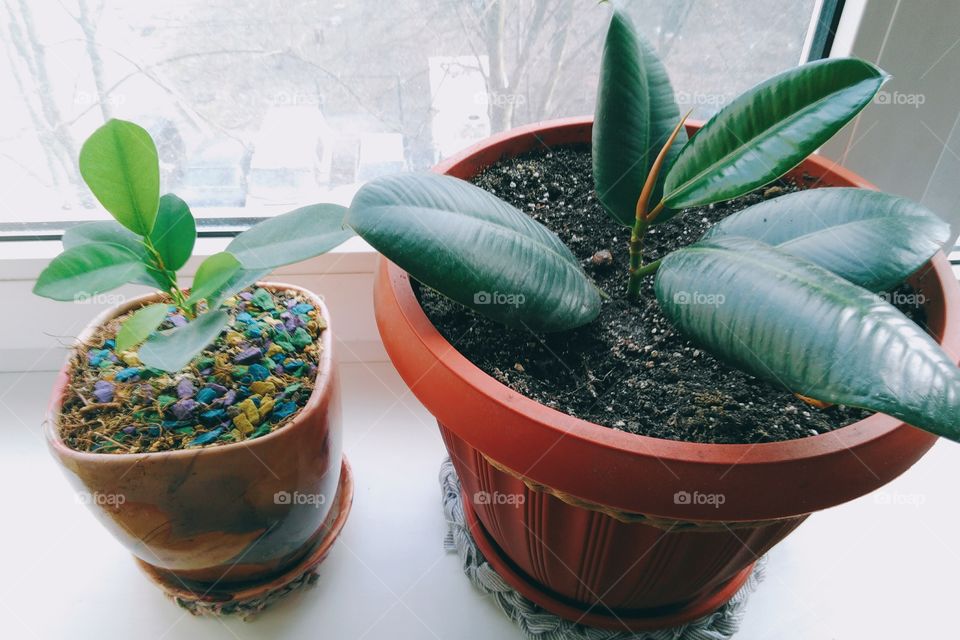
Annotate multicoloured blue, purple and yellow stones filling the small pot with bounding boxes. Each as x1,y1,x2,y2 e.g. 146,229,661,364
58,289,326,453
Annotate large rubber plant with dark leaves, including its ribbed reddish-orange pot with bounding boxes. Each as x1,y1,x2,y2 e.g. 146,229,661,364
348,11,960,630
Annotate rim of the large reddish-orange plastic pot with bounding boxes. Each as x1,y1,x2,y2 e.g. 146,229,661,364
379,116,960,466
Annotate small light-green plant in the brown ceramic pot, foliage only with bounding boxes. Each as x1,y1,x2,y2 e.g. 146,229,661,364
34,120,352,372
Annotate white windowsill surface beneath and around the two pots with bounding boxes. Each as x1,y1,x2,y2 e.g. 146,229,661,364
0,363,960,640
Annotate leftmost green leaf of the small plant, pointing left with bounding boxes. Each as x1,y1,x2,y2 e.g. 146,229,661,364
33,243,147,301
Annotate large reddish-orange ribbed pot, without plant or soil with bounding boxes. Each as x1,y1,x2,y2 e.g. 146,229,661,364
375,119,960,630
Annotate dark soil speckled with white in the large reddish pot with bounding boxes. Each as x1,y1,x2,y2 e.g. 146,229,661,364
415,146,923,443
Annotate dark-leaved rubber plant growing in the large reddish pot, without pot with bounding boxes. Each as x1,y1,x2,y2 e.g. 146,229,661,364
348,10,960,440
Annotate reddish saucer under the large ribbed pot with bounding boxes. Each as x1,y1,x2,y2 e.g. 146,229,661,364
462,500,753,631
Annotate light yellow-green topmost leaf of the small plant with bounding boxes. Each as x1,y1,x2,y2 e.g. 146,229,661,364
80,120,160,237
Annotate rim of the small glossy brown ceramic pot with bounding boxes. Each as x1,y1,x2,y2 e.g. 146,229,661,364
43,281,334,463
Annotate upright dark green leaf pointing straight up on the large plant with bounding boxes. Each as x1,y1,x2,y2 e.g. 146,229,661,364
593,10,687,226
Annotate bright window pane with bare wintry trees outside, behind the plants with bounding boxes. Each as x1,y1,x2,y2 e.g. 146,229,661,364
0,0,821,230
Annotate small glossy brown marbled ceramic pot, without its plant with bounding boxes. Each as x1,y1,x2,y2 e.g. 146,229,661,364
46,284,350,598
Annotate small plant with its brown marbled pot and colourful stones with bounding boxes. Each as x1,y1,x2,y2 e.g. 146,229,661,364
34,120,352,612
